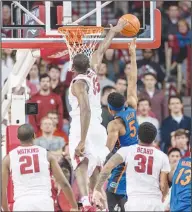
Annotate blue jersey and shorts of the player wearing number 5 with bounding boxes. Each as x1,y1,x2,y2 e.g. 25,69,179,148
107,107,139,195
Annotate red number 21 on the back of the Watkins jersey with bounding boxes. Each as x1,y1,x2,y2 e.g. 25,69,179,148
19,154,40,174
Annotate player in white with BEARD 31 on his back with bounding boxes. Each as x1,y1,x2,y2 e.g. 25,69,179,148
93,122,170,211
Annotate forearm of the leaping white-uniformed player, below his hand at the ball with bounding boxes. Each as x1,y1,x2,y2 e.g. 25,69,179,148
97,29,117,54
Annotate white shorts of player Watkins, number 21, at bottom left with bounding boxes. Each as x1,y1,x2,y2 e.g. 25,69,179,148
13,196,54,211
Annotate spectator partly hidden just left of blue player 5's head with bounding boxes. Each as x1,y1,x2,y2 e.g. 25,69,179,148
101,86,115,128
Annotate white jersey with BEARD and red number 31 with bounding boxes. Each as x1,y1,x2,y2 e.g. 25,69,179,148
117,144,170,199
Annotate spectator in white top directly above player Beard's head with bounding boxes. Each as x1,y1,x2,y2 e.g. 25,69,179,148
137,98,160,143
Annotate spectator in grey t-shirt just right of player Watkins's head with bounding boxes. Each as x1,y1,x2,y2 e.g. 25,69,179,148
34,117,65,155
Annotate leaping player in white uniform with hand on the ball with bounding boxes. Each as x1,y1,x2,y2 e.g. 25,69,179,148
69,20,127,211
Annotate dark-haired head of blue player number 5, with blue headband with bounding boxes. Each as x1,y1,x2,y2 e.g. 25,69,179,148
107,92,125,115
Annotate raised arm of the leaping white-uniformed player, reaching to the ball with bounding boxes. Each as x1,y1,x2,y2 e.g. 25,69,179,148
90,19,127,72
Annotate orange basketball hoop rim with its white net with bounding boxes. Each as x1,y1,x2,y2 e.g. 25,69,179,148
58,26,104,61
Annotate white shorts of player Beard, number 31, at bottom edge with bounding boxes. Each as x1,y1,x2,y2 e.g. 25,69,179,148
125,196,164,212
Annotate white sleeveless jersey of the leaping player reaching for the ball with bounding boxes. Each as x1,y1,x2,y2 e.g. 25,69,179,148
69,69,102,126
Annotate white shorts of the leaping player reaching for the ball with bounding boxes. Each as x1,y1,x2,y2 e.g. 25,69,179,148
69,121,107,177
